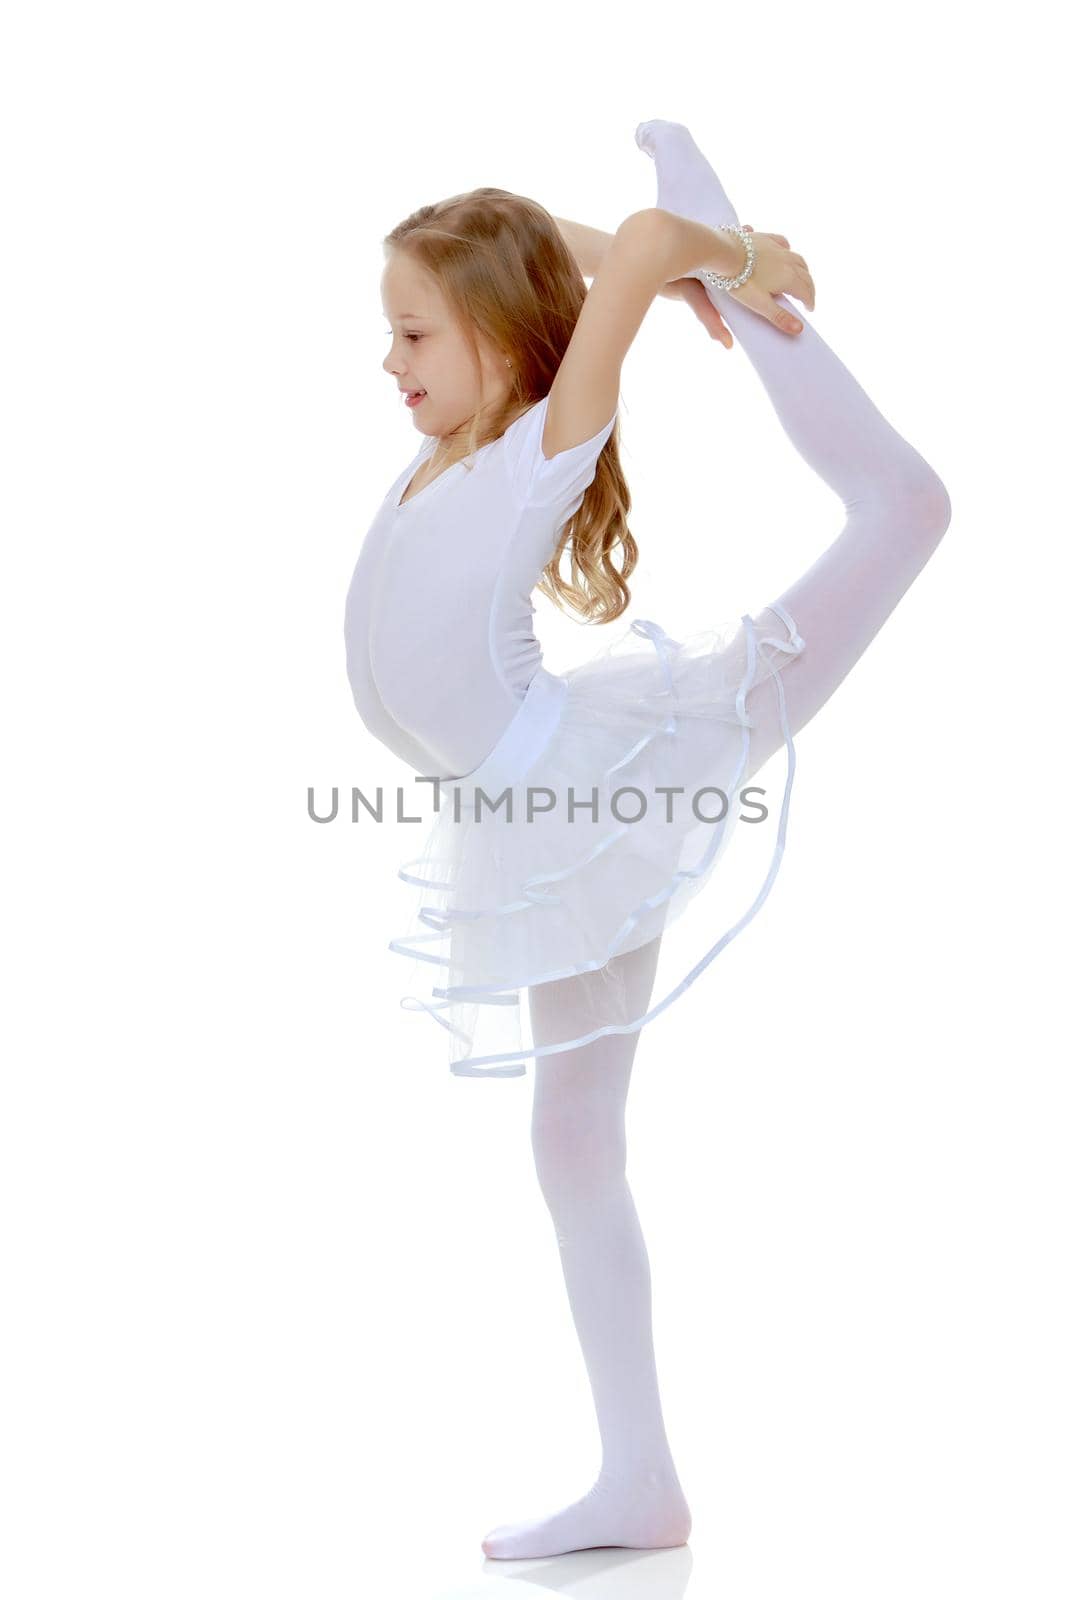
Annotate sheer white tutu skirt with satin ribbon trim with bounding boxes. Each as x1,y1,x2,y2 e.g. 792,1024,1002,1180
389,605,805,1077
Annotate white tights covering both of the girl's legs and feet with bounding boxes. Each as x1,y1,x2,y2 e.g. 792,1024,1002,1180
483,122,950,1557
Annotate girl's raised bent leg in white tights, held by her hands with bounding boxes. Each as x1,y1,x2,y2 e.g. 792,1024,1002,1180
635,120,952,773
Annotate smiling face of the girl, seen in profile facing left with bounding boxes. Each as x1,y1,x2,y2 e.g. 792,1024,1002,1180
381,250,510,438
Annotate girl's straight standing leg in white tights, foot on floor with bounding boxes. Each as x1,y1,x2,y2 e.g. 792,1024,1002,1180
482,939,691,1557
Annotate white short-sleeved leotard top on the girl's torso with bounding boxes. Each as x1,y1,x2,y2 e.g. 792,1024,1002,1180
344,395,617,776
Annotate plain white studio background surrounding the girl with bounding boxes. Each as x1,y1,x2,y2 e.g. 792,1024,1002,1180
0,0,1067,1600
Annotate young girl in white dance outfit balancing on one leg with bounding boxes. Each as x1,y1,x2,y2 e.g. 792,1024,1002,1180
346,122,950,1557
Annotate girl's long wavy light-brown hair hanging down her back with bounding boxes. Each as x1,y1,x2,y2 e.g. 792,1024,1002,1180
382,189,638,624
